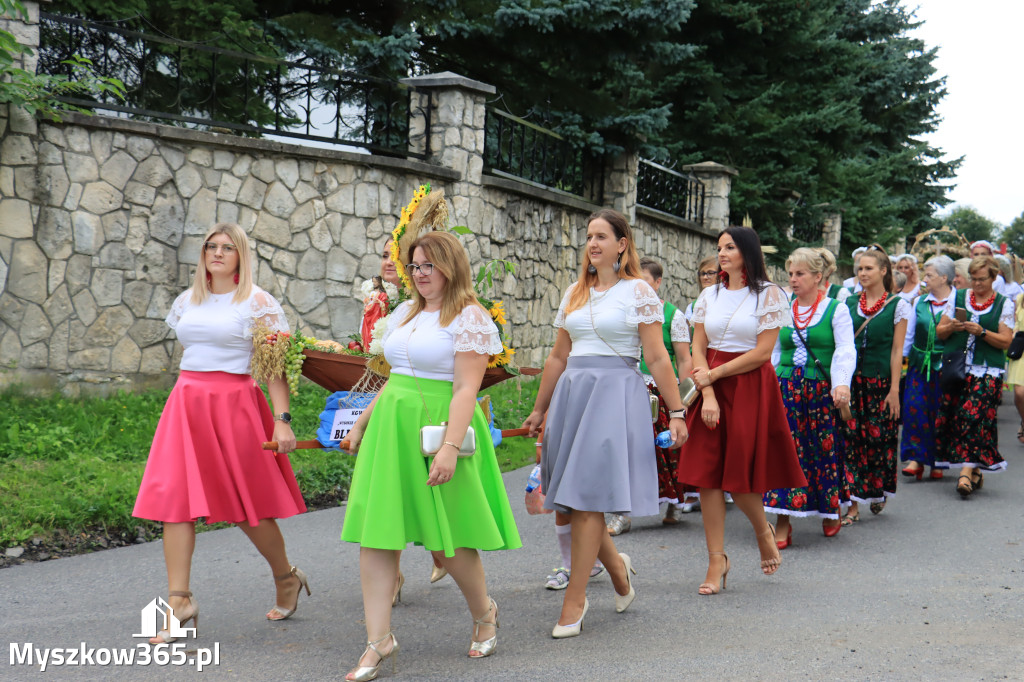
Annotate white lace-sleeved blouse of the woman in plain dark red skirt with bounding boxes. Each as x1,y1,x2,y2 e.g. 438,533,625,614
692,283,792,353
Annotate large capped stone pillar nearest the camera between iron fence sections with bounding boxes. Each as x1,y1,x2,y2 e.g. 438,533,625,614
401,71,497,184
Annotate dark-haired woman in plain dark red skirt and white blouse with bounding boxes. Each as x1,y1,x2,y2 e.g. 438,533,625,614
679,226,807,595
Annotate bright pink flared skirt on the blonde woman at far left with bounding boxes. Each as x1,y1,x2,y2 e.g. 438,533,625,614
132,371,306,525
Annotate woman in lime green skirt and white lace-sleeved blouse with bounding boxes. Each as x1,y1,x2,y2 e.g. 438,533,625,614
341,231,522,680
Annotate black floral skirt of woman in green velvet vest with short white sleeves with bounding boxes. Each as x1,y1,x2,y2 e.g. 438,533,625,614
844,374,899,503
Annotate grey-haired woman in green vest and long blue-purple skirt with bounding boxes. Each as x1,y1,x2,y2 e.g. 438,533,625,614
900,251,956,480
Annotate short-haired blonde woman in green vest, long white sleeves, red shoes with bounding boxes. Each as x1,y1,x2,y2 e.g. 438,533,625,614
764,249,857,549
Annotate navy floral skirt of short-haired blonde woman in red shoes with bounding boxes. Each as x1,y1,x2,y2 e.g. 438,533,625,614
764,368,850,518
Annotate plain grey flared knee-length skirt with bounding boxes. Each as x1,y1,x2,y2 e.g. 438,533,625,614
541,355,657,516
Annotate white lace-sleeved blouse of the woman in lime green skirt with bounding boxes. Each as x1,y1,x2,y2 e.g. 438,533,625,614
382,301,502,381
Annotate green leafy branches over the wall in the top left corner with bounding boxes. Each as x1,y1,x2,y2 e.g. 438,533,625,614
0,0,124,120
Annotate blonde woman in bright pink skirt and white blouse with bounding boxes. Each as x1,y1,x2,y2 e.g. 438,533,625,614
132,223,309,644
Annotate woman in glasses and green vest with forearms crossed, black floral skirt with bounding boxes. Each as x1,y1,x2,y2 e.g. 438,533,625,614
935,256,1014,498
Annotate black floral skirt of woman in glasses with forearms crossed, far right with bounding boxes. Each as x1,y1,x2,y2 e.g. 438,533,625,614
935,374,1007,471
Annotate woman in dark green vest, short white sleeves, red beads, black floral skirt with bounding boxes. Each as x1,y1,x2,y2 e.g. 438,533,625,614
843,244,913,525
